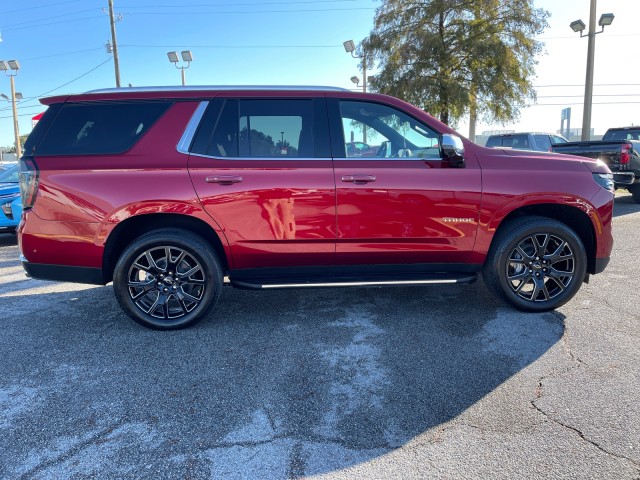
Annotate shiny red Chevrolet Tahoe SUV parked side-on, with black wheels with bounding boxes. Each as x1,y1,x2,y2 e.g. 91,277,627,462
19,87,613,329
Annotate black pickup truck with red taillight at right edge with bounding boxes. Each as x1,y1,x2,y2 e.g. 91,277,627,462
551,126,640,203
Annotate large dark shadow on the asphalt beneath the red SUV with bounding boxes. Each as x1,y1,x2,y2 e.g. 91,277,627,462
0,283,564,479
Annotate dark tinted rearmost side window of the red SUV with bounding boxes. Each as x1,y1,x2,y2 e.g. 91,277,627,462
37,102,171,155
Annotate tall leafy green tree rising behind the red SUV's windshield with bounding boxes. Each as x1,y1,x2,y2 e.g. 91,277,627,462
361,0,549,129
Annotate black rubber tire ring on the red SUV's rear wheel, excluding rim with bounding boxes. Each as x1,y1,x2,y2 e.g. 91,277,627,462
113,229,222,330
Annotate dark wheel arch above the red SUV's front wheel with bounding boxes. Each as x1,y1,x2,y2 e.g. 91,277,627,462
485,203,596,273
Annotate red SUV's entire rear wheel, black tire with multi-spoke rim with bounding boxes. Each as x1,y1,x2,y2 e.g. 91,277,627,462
113,228,222,330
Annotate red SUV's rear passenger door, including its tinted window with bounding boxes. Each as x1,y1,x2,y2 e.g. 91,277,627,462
189,98,336,269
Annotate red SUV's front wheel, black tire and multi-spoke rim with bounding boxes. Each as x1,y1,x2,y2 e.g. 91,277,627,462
482,216,587,312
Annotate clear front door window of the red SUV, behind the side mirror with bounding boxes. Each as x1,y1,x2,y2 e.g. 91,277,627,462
340,101,441,159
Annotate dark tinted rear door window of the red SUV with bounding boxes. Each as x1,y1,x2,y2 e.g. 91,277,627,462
199,99,315,158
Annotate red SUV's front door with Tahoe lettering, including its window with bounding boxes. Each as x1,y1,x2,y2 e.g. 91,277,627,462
328,99,481,264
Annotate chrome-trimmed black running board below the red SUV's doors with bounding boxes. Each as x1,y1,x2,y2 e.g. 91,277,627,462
229,274,478,290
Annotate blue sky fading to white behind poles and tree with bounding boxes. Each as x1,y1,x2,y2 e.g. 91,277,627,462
0,0,640,146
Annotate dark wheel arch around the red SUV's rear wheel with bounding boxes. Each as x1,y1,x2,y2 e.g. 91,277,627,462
102,213,234,283
